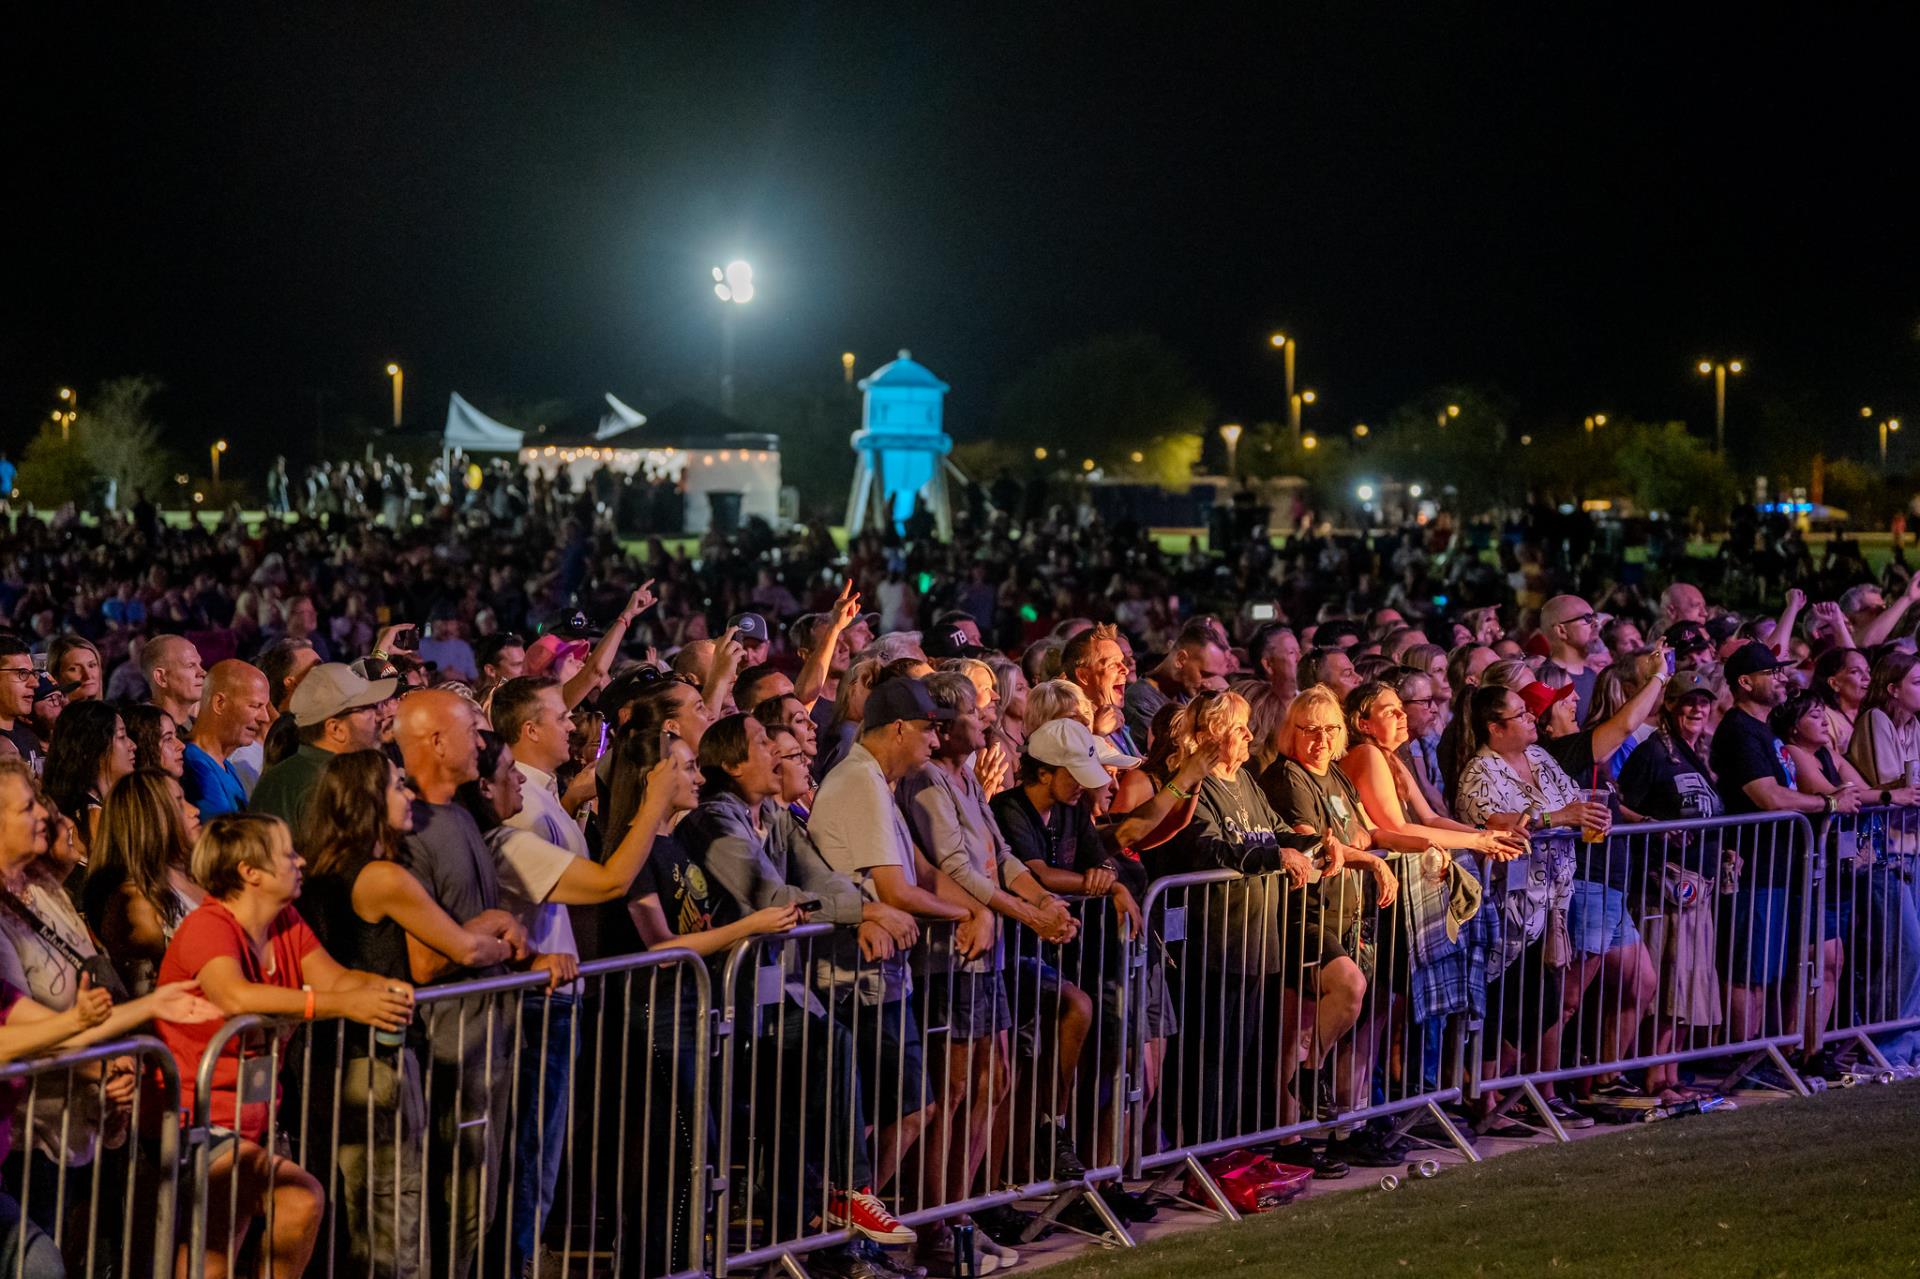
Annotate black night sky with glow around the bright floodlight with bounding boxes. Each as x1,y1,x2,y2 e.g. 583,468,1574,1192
0,2,1920,461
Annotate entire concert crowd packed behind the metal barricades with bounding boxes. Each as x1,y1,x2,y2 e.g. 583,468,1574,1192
0,472,1920,1279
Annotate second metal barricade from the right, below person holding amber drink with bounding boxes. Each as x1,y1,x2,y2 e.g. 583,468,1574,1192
1471,812,1820,1141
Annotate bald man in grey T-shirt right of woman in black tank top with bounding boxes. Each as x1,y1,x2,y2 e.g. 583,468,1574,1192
394,689,526,1275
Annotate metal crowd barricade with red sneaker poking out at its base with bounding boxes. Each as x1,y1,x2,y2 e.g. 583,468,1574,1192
714,897,1135,1275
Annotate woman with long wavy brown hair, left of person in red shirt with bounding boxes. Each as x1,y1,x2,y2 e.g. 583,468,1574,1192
83,770,205,995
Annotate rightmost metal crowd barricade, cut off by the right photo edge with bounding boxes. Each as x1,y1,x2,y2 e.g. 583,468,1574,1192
1811,807,1920,1072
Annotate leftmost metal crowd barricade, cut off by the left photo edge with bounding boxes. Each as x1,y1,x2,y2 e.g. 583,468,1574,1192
0,1035,180,1279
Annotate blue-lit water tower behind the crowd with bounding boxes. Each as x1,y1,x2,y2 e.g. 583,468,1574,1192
847,351,954,542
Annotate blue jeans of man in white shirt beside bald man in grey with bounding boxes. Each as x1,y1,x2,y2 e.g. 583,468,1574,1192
509,991,578,1275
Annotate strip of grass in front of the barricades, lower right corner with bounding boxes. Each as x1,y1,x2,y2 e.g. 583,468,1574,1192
1046,1083,1920,1279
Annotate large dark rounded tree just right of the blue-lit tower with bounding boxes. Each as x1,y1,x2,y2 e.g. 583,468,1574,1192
996,334,1213,490
